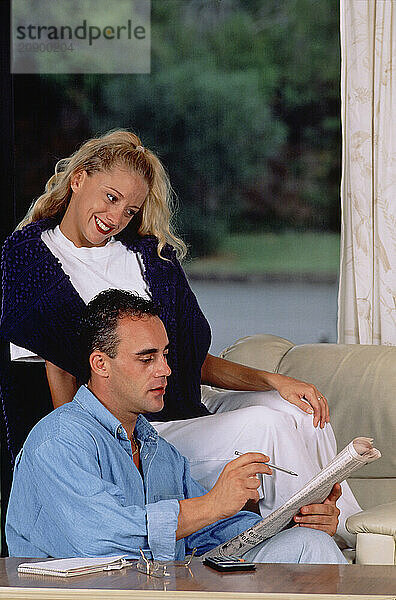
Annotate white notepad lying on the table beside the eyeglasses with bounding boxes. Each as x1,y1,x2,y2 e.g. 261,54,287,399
18,554,130,577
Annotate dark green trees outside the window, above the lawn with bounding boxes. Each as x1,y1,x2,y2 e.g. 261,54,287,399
27,0,340,255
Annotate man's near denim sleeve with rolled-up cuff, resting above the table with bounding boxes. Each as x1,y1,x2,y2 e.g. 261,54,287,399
29,439,179,560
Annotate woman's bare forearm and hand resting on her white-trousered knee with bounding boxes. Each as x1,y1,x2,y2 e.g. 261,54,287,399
201,354,330,428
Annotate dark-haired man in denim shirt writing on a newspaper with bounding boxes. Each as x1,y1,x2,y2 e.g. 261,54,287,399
6,290,345,563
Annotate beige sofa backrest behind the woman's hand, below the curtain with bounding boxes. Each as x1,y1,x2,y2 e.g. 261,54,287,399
279,344,396,478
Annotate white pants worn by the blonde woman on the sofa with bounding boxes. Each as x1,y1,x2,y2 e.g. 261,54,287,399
152,386,362,546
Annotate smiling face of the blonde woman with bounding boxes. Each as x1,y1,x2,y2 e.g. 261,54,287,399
60,166,149,248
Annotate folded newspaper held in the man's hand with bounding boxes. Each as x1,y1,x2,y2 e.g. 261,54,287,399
205,437,381,557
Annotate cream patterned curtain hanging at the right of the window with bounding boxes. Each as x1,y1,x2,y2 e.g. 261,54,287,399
338,0,396,345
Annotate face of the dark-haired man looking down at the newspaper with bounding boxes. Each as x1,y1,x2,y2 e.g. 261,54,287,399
102,315,171,414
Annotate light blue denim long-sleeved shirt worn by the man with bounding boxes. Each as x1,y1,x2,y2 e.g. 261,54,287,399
6,386,260,560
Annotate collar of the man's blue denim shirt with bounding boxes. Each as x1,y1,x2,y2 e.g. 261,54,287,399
73,385,158,441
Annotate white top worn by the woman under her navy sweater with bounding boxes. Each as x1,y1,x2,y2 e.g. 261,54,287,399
10,225,150,362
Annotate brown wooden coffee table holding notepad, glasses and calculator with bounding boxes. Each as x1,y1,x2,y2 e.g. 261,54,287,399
0,558,396,600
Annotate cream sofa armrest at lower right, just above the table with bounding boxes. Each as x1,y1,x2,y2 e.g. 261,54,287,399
346,502,396,565
